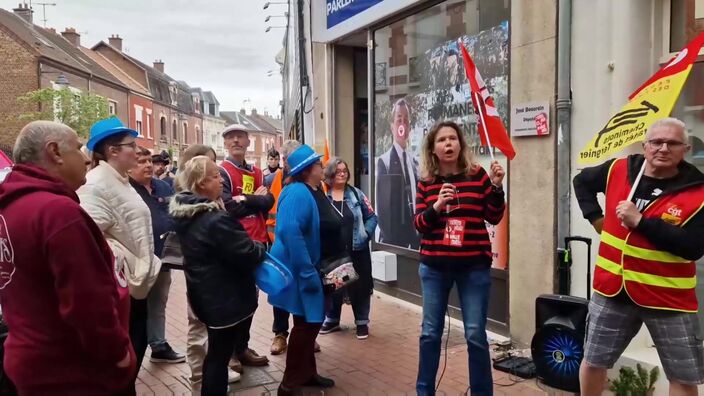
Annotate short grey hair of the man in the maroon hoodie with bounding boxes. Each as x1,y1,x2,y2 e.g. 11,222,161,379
12,121,76,164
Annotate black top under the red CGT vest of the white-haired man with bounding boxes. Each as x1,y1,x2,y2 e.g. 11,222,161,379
573,154,704,260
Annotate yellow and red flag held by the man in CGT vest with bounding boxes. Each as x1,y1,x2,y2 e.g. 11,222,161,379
577,33,704,164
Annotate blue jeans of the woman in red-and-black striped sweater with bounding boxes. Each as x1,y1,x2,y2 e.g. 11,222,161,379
416,263,493,396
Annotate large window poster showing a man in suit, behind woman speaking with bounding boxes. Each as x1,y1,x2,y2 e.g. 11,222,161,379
373,21,509,268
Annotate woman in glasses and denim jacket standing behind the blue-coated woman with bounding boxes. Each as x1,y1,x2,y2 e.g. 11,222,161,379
320,158,377,340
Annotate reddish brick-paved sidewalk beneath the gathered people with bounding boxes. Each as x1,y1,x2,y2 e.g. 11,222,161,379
137,271,547,396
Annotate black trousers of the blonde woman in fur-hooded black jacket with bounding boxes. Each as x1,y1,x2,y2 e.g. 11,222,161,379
201,317,252,395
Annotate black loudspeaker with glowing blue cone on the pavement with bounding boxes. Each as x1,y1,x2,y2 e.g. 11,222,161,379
531,294,589,392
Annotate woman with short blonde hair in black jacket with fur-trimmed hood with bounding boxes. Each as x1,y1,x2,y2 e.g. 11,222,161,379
169,156,266,395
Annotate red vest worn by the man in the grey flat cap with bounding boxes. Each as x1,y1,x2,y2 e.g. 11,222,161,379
221,160,267,243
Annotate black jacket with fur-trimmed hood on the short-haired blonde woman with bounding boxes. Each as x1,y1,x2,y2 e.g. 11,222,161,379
169,192,265,328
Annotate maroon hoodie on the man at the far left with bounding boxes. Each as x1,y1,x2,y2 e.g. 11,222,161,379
0,165,135,395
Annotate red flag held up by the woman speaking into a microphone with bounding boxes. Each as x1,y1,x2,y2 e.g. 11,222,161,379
460,42,516,160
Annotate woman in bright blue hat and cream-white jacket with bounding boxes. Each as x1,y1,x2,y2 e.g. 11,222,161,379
77,117,161,394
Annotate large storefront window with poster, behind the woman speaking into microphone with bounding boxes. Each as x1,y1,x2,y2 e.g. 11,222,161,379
371,0,510,268
